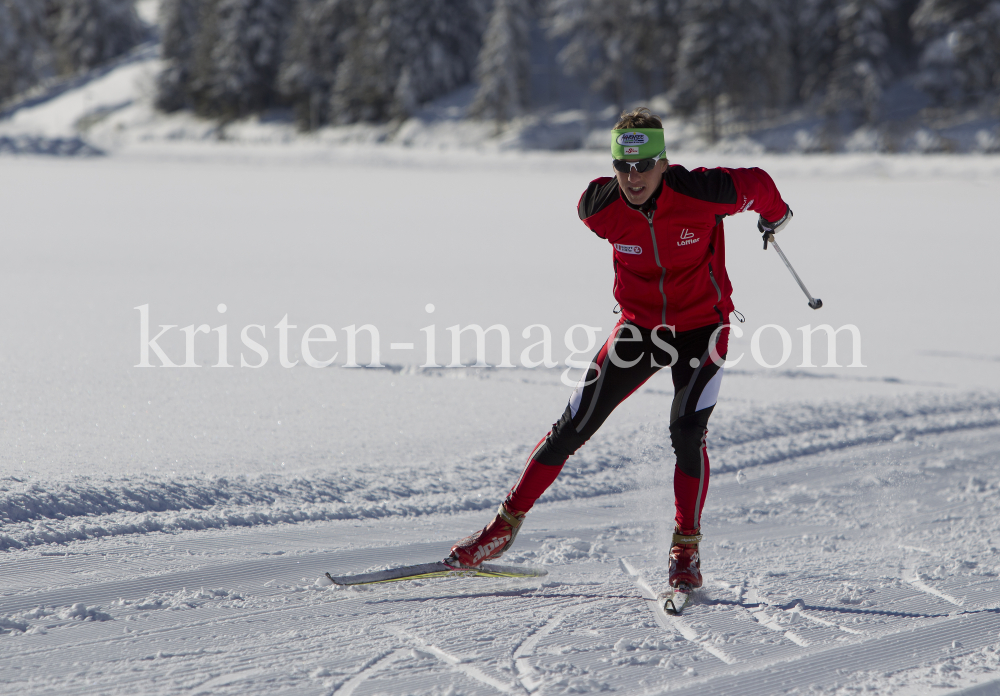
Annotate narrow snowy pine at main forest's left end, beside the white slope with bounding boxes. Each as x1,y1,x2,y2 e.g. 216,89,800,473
156,0,204,112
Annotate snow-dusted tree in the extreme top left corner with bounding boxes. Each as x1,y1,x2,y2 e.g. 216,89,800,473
0,0,51,104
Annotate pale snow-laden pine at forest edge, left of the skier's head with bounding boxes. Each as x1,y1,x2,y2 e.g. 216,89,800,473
469,0,531,124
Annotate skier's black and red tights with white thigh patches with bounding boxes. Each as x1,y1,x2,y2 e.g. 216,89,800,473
507,319,729,532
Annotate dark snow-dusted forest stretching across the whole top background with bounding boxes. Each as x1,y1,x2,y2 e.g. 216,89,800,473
0,0,1000,136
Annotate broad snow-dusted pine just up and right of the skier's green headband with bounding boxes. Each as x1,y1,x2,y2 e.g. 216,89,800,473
671,0,791,142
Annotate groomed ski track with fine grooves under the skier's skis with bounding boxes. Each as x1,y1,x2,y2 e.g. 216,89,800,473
0,426,1000,696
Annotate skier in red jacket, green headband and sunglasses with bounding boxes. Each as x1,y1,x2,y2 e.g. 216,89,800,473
451,108,792,589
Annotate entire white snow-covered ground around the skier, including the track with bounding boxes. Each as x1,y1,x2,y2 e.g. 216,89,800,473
0,50,1000,696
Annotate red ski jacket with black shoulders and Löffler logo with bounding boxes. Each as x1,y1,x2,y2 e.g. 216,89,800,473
577,164,788,331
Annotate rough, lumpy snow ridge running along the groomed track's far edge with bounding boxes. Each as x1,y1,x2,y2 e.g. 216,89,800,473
0,372,1000,549
